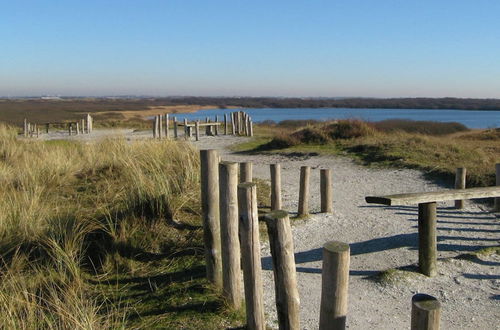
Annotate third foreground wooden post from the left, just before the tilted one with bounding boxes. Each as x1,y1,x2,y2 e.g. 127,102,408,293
238,183,266,330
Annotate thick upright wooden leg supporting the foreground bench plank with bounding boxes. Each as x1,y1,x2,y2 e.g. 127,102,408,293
418,202,437,277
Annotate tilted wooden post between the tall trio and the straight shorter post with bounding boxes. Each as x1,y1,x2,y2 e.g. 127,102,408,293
265,210,300,329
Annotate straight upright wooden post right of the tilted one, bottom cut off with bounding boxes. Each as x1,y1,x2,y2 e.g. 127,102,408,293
319,241,350,330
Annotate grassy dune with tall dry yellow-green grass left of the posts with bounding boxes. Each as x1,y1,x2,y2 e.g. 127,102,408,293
0,126,242,329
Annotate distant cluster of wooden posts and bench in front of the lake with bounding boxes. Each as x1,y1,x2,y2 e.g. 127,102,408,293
153,111,253,141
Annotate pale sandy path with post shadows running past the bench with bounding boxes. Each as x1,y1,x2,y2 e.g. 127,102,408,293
33,130,500,329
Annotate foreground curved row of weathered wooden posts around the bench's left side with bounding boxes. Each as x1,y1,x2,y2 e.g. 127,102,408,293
200,150,440,330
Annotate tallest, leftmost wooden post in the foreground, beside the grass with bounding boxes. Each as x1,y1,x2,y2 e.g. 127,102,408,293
200,149,222,288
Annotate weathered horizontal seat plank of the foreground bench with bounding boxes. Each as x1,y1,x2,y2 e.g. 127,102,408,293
365,186,500,206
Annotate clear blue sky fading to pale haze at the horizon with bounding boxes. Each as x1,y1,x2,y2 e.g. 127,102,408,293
0,0,500,98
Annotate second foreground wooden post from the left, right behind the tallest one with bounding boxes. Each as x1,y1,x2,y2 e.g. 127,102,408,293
219,162,242,308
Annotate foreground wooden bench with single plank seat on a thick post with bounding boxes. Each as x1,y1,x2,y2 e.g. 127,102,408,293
365,186,500,276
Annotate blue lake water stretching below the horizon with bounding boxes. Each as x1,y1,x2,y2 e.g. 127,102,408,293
175,108,500,128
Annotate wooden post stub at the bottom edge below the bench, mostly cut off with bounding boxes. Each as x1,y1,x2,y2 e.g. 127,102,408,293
411,293,441,330
